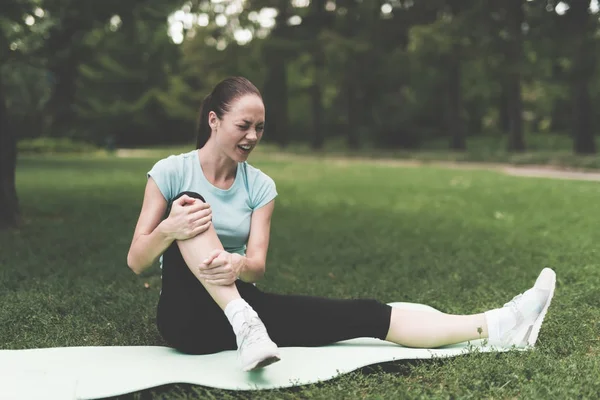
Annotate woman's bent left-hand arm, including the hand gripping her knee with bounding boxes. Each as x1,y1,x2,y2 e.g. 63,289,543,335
127,178,210,274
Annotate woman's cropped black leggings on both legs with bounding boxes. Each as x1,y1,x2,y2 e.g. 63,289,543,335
157,192,392,354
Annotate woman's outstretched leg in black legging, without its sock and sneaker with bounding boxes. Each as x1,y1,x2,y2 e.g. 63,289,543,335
242,289,488,348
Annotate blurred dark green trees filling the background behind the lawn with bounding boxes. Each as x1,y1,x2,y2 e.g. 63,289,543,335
0,0,600,226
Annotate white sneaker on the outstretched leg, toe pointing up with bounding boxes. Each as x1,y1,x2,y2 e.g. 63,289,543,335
490,268,556,347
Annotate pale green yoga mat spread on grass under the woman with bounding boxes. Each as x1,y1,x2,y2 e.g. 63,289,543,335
0,303,524,400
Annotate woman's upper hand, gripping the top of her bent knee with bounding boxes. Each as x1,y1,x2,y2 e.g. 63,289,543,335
161,195,212,240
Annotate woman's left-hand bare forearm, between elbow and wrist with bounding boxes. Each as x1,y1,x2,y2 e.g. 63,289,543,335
127,223,173,274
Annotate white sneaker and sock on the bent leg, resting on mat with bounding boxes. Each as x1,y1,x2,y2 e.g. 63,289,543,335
236,308,281,371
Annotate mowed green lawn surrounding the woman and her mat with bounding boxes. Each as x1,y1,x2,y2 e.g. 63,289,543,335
0,153,600,399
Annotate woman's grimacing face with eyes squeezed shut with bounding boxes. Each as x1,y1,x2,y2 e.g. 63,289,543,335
208,94,265,162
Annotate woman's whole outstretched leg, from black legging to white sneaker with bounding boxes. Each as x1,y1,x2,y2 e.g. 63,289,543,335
242,268,556,348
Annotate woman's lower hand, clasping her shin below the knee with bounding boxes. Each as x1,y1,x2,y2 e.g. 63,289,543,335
199,249,244,286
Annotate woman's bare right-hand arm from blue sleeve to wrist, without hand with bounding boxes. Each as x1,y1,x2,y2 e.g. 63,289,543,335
239,200,275,282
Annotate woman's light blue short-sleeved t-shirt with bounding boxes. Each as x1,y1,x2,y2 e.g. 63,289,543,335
148,150,277,256
